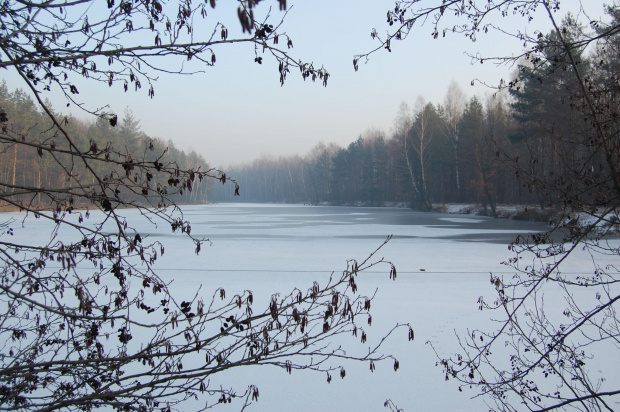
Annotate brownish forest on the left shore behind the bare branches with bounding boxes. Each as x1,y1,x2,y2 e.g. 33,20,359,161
0,81,213,207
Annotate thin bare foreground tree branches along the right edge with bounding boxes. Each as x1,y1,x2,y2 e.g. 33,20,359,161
364,0,620,411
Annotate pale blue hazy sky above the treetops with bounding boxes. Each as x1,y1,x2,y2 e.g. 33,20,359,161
1,0,602,167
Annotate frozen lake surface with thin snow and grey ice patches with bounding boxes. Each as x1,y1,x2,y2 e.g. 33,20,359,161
4,204,612,411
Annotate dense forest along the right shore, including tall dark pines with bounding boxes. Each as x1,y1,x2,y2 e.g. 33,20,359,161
211,16,619,215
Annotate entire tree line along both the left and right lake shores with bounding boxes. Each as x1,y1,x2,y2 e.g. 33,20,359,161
0,11,620,215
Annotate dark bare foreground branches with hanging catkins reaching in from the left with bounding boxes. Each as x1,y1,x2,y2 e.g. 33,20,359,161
0,0,413,410
